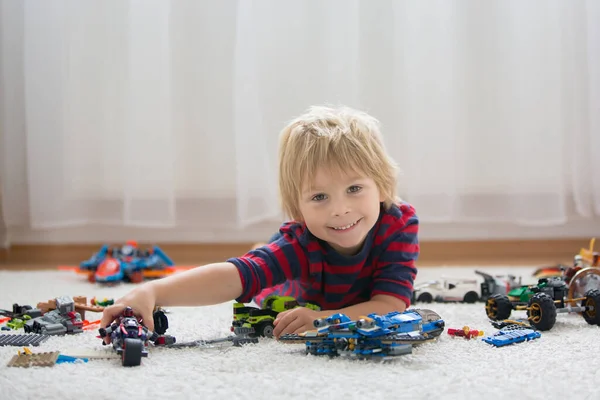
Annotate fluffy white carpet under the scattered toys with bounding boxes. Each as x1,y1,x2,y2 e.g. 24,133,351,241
0,267,600,400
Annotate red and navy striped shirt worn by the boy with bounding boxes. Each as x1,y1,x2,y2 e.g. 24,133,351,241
227,202,419,310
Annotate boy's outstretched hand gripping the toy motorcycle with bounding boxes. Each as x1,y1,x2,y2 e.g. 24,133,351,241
100,283,156,344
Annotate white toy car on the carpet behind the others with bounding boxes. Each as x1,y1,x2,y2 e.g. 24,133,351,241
413,271,520,303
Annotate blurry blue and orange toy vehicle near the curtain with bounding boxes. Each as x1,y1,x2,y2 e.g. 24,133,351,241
59,241,192,283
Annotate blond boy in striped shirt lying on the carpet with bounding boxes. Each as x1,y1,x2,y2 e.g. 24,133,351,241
101,107,419,337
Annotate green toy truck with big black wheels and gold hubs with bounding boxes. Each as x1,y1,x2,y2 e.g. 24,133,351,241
485,277,600,331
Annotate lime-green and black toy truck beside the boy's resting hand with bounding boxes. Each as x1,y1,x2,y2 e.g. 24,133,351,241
231,295,320,337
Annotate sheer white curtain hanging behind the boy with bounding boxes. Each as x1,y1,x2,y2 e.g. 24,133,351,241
0,0,600,240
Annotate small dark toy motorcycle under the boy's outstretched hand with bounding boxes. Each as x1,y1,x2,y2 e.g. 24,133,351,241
99,307,159,367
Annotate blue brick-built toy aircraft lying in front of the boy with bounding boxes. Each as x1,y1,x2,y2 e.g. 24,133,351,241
279,309,445,360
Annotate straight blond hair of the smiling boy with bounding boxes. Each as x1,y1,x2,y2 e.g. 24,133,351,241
279,106,398,221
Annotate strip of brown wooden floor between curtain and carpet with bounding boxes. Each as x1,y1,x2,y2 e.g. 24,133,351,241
0,238,589,270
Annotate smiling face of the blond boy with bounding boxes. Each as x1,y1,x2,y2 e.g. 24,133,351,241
300,167,384,255
